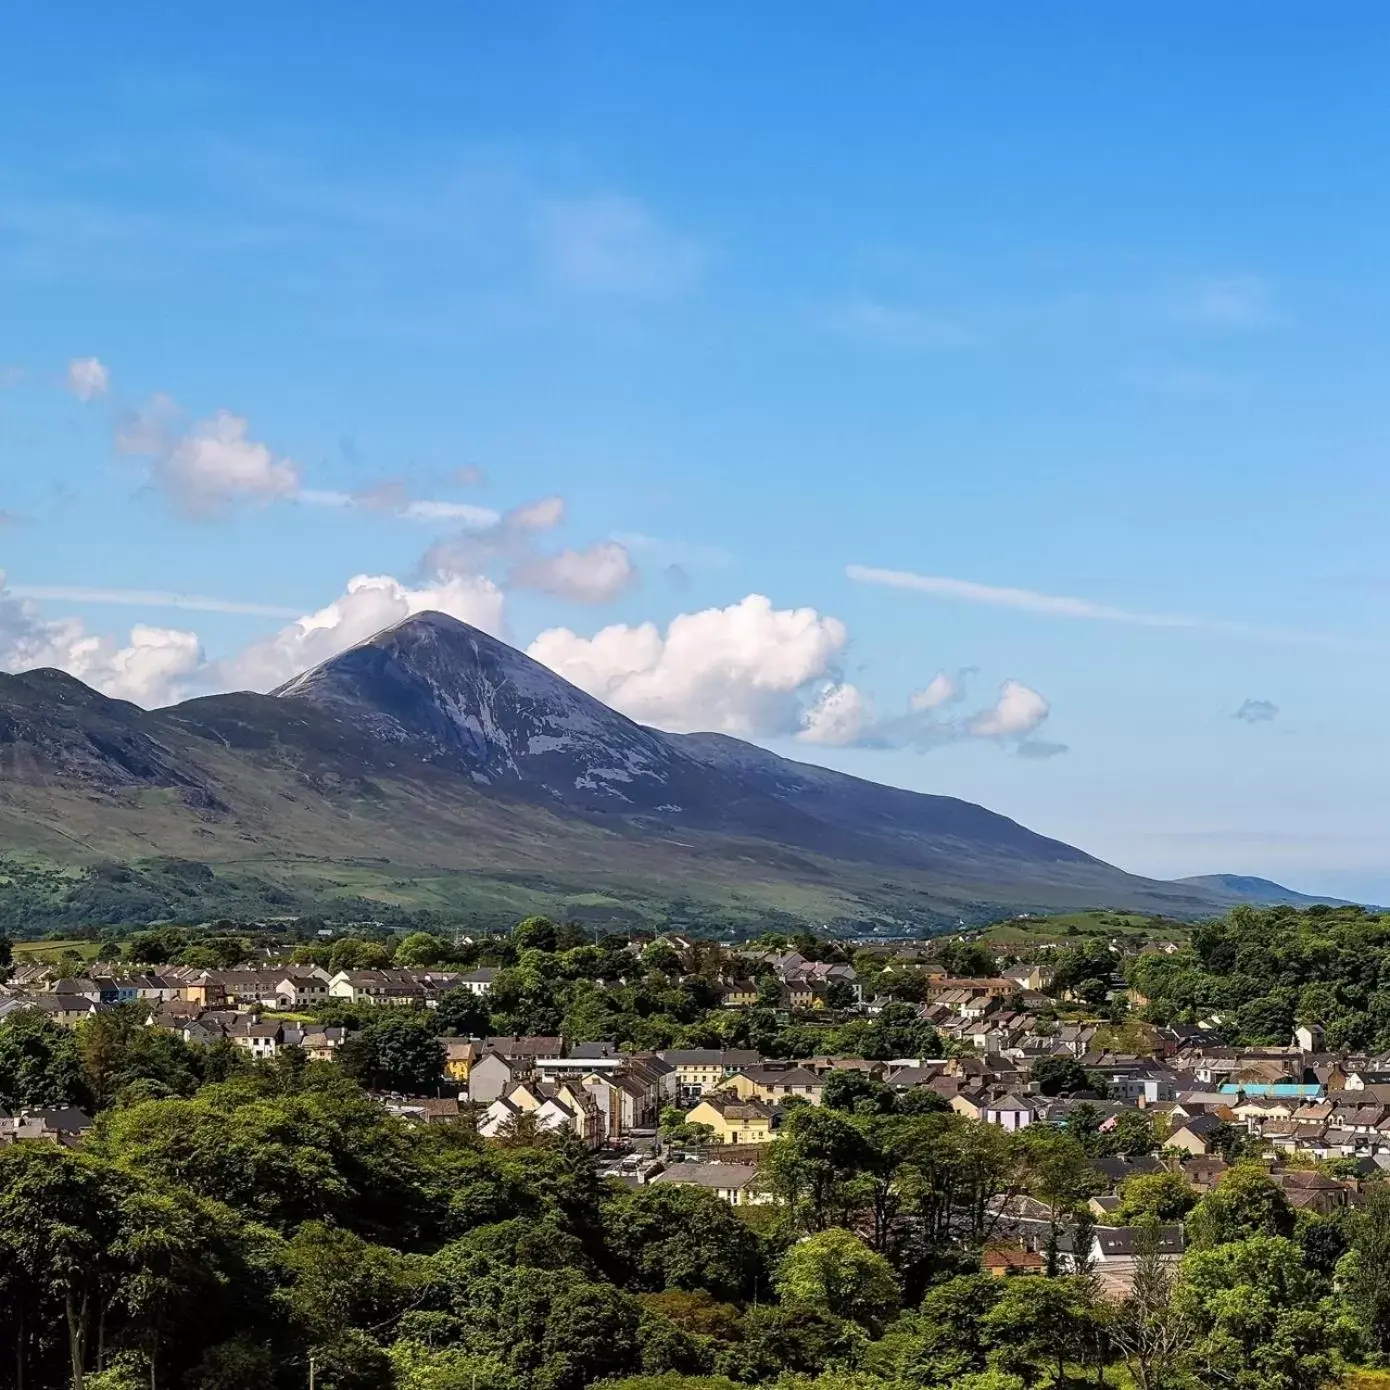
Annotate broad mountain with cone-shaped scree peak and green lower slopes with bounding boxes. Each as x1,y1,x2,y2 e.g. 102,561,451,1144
0,613,1256,930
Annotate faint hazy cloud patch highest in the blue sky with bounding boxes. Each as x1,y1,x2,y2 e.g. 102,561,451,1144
534,195,705,299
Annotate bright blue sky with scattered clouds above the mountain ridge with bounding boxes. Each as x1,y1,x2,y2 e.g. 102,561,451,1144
0,3,1390,901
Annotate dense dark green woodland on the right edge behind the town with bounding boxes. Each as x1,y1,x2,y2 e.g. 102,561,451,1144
1126,906,1390,1052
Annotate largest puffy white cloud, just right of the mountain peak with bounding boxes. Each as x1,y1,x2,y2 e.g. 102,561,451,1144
528,594,848,737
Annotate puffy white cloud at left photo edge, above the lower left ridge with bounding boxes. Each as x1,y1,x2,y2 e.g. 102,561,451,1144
0,574,202,705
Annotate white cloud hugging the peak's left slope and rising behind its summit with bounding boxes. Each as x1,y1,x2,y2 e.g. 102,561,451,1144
211,574,503,691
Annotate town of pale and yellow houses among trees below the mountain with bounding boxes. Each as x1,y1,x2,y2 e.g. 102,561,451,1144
0,919,1390,1295
